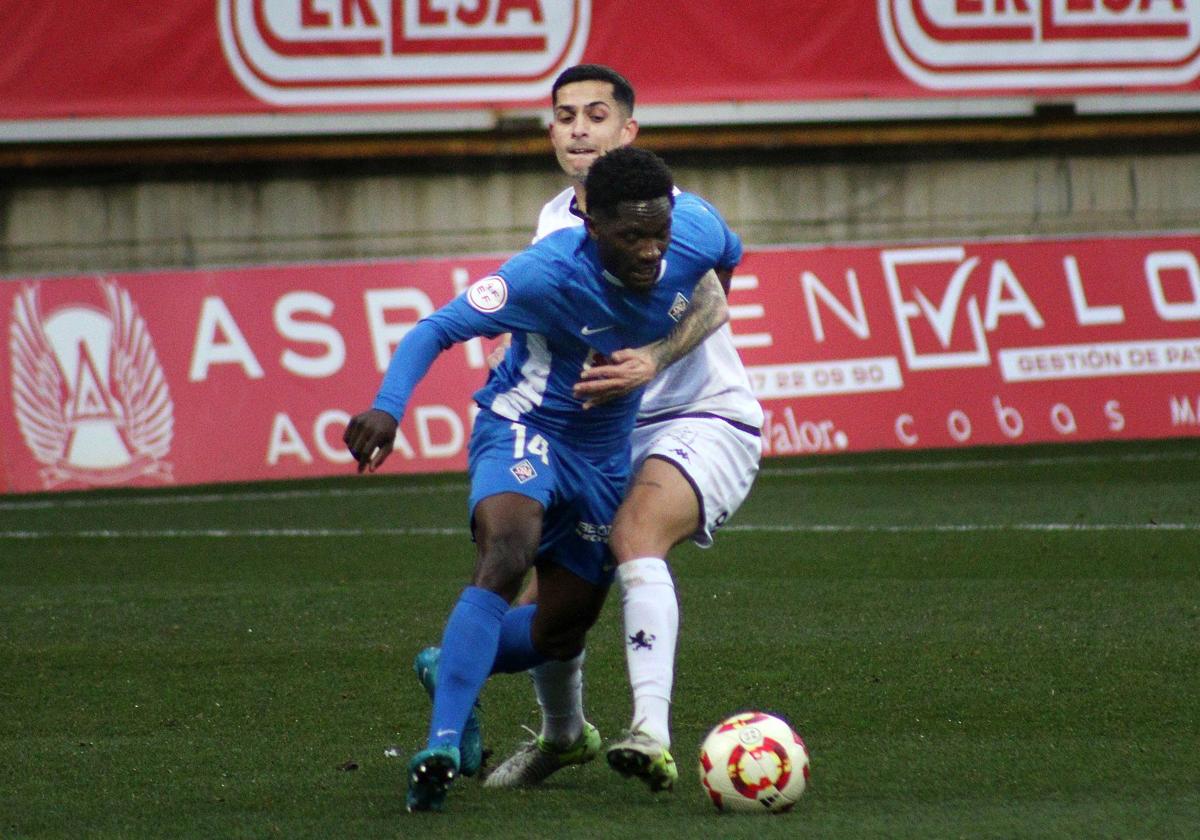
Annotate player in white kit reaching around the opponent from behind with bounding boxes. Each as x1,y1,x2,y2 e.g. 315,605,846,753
485,65,763,792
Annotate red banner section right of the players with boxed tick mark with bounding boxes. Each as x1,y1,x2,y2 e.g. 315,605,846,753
731,235,1200,455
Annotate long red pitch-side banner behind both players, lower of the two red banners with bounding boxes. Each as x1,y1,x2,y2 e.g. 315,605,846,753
0,234,1200,492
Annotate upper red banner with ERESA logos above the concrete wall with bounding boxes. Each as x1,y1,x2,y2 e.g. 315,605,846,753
0,0,1200,140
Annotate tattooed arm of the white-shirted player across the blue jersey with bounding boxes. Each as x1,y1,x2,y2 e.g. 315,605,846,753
575,270,730,408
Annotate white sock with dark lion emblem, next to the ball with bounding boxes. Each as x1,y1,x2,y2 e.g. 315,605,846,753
617,557,679,746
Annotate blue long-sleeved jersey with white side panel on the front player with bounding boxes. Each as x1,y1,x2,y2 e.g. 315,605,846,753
374,193,742,454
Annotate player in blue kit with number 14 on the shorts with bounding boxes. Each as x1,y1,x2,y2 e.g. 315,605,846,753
343,148,740,811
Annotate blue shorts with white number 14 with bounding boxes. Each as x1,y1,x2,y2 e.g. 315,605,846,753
467,409,629,586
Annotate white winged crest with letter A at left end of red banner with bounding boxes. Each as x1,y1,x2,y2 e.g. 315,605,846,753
8,280,174,490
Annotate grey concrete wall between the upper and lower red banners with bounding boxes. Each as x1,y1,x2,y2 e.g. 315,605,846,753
0,144,1200,277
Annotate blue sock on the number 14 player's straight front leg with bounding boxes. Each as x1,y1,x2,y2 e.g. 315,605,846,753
427,587,509,748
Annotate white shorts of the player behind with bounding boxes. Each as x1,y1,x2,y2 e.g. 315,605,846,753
632,416,762,548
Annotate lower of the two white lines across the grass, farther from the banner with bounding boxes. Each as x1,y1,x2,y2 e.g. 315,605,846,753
0,522,1200,540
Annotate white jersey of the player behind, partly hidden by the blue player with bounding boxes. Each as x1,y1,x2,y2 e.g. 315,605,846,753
533,187,763,433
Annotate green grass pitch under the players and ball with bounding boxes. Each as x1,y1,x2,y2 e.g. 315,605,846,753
0,438,1200,840
